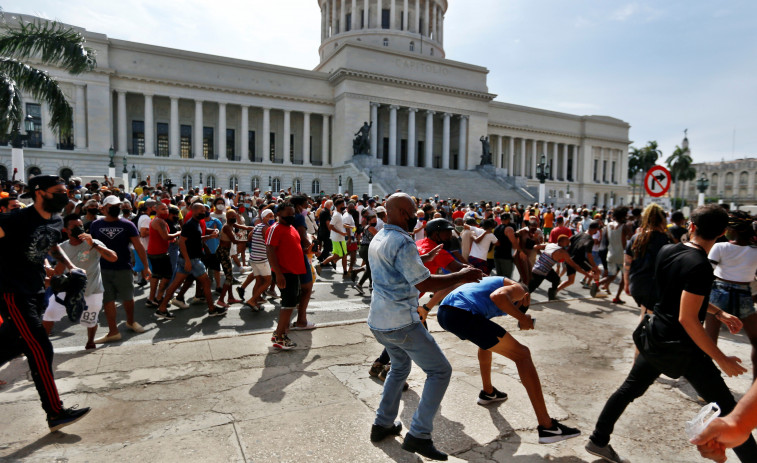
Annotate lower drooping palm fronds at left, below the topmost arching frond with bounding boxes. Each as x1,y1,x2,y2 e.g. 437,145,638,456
0,58,73,136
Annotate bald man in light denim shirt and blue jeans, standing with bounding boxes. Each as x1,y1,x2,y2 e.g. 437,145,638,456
368,193,483,460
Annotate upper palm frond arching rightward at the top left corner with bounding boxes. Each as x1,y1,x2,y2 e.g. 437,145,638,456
0,21,97,74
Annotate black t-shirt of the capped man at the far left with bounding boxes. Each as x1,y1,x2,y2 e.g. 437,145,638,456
0,206,63,296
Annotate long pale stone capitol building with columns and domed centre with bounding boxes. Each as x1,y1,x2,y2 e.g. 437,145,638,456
0,0,630,206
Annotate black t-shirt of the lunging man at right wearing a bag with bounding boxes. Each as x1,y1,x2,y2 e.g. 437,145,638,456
654,243,715,345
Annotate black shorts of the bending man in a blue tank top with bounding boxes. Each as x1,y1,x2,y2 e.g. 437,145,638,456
436,305,507,350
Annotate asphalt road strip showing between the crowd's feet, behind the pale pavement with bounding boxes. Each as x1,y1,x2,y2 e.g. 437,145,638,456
50,262,616,352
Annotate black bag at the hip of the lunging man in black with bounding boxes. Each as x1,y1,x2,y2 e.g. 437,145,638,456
633,314,695,379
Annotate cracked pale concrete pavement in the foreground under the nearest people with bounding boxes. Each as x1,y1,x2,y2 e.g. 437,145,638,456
0,300,751,463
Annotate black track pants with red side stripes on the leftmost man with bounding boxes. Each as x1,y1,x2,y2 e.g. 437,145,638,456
0,293,63,415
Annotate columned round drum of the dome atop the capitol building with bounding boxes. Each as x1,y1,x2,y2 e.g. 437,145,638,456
318,0,447,62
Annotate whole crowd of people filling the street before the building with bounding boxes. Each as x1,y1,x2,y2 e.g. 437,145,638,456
0,172,757,462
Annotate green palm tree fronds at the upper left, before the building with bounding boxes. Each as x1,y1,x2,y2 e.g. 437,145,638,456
0,15,97,143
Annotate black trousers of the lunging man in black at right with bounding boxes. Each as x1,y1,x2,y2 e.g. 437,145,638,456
590,353,757,462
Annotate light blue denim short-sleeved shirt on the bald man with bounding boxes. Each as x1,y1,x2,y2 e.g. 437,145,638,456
368,224,431,331
